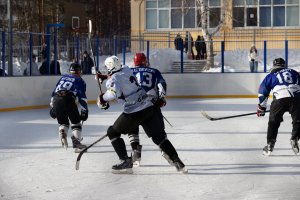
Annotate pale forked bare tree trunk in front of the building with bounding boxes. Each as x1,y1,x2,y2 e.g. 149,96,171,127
196,0,227,70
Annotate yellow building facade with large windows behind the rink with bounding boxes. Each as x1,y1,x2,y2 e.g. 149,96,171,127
131,0,300,49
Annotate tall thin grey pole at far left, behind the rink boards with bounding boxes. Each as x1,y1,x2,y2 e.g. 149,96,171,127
7,0,13,76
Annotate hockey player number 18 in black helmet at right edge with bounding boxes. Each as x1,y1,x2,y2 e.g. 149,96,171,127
257,58,300,155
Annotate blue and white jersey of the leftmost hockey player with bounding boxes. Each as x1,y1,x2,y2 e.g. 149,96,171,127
52,74,88,110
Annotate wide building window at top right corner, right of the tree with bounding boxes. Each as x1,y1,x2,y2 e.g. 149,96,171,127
232,0,300,27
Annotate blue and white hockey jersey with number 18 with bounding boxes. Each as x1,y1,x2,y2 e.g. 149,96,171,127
258,68,300,108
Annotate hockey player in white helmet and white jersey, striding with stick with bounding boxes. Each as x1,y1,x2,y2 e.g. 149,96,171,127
96,56,187,173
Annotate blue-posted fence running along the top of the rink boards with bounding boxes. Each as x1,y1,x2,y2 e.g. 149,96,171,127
0,32,300,76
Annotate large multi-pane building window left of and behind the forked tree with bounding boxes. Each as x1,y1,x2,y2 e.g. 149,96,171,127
146,0,221,30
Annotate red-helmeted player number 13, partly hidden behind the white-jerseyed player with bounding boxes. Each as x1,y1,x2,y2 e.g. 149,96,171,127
128,53,172,166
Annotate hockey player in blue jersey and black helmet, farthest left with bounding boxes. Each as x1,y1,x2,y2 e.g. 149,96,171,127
50,63,88,152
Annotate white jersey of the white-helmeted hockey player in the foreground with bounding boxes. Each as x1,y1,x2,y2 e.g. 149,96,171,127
103,65,153,113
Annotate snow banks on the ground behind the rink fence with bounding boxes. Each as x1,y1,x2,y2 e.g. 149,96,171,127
6,49,300,76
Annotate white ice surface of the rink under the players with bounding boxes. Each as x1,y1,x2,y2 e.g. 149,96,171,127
0,99,300,200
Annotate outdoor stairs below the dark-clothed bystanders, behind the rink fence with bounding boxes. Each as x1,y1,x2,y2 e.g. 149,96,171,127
168,60,206,73
